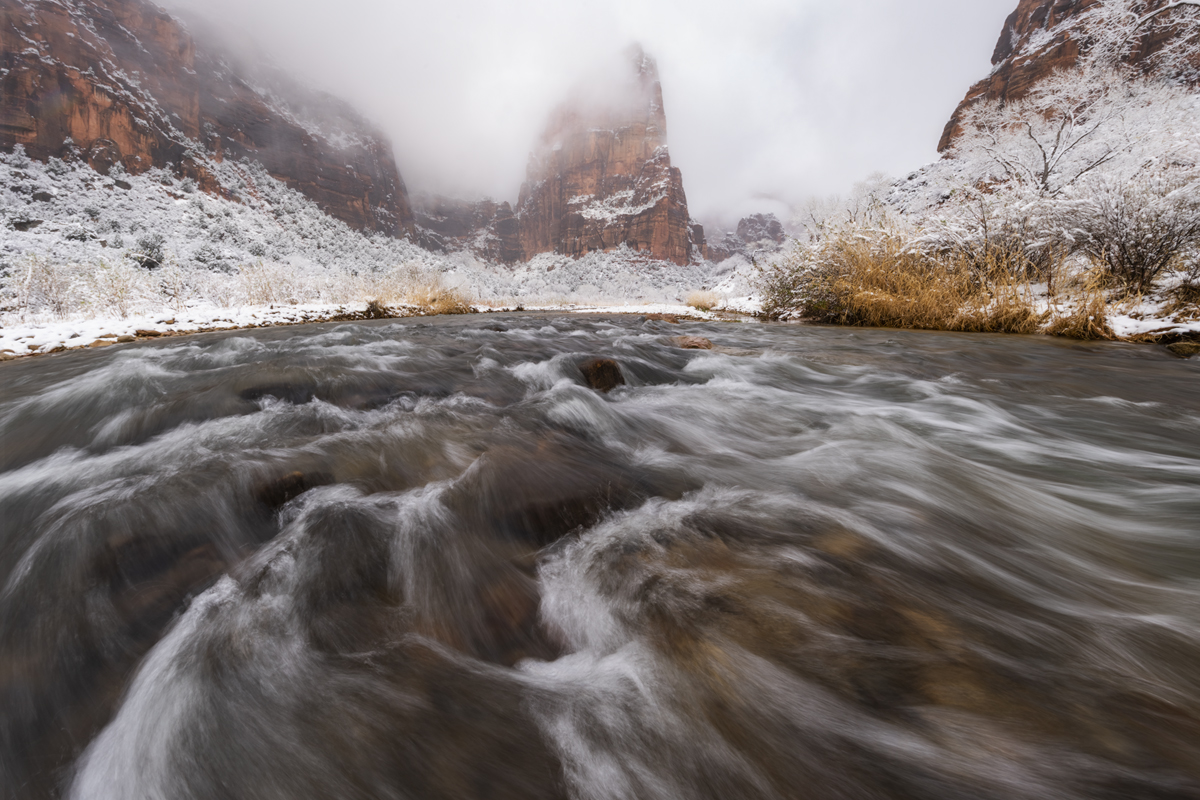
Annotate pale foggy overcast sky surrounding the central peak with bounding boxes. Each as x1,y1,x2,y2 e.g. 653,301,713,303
160,0,1016,225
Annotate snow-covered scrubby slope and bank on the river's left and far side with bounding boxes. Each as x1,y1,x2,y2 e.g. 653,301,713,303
0,148,754,357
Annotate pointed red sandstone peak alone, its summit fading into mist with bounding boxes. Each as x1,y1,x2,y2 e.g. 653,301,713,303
517,48,704,264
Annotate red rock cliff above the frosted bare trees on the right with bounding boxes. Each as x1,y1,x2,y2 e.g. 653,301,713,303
938,0,1200,151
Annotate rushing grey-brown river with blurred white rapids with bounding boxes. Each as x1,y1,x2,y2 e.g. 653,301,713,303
0,315,1200,800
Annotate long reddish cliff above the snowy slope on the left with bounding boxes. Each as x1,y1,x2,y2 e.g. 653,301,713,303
0,0,413,236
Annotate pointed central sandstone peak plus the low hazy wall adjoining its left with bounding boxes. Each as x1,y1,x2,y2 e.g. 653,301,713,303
414,47,708,264
